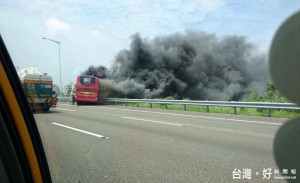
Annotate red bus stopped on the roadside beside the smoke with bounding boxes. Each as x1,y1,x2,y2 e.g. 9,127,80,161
75,75,99,105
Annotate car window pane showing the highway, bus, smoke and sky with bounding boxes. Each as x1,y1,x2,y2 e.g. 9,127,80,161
0,0,300,183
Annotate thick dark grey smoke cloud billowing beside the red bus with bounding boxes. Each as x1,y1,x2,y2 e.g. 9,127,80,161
83,31,270,100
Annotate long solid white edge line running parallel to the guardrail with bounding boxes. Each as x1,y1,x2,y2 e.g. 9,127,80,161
85,106,283,126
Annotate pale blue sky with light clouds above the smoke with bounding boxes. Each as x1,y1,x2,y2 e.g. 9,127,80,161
0,0,300,88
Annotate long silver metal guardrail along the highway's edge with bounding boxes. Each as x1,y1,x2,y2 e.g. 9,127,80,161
107,98,300,117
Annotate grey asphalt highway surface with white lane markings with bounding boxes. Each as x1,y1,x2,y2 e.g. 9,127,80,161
34,104,287,183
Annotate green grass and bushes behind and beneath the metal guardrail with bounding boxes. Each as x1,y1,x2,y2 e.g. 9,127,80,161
119,84,300,118
